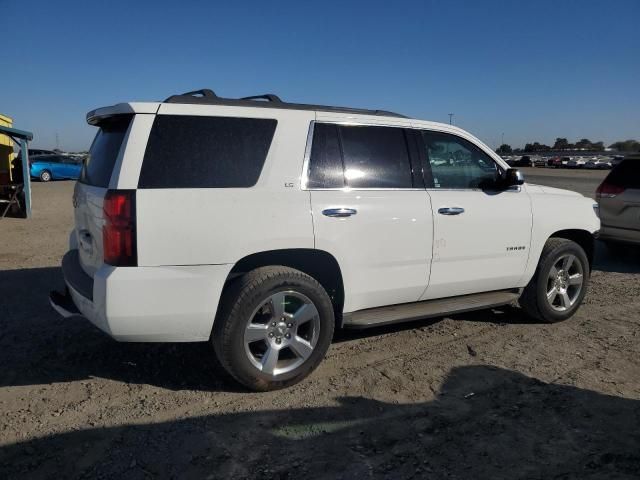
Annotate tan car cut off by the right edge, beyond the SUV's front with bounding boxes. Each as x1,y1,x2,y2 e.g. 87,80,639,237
596,155,640,246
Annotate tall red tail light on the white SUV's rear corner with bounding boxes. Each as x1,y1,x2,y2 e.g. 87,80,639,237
102,190,138,267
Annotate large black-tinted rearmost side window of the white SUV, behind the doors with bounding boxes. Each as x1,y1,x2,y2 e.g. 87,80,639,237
138,115,277,188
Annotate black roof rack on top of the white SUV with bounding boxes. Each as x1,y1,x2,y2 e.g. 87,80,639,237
163,88,406,118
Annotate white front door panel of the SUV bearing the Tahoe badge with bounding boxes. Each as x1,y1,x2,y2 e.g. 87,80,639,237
421,189,532,300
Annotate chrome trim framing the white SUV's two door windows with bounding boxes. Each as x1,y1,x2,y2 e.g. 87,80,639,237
300,120,521,192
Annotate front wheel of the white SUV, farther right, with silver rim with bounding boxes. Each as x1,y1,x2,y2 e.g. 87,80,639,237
519,238,590,323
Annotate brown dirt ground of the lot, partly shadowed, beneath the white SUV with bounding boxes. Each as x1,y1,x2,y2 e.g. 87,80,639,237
0,173,640,479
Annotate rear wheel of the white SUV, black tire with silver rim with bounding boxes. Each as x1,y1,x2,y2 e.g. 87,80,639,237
212,266,335,391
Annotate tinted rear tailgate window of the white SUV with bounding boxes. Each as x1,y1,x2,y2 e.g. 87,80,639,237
79,115,133,188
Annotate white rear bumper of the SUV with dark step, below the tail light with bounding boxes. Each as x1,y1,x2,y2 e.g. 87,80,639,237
50,250,232,342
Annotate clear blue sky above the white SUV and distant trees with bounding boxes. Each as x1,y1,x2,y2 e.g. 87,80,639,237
0,0,640,150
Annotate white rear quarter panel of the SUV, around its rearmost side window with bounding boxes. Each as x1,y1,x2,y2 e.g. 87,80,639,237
129,104,315,266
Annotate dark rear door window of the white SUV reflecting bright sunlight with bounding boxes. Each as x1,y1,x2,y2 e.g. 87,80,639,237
308,124,413,188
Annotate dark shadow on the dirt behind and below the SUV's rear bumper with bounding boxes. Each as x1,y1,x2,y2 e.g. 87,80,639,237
0,268,239,391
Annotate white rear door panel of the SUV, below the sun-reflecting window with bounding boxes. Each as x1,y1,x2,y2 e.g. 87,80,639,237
310,190,433,312
